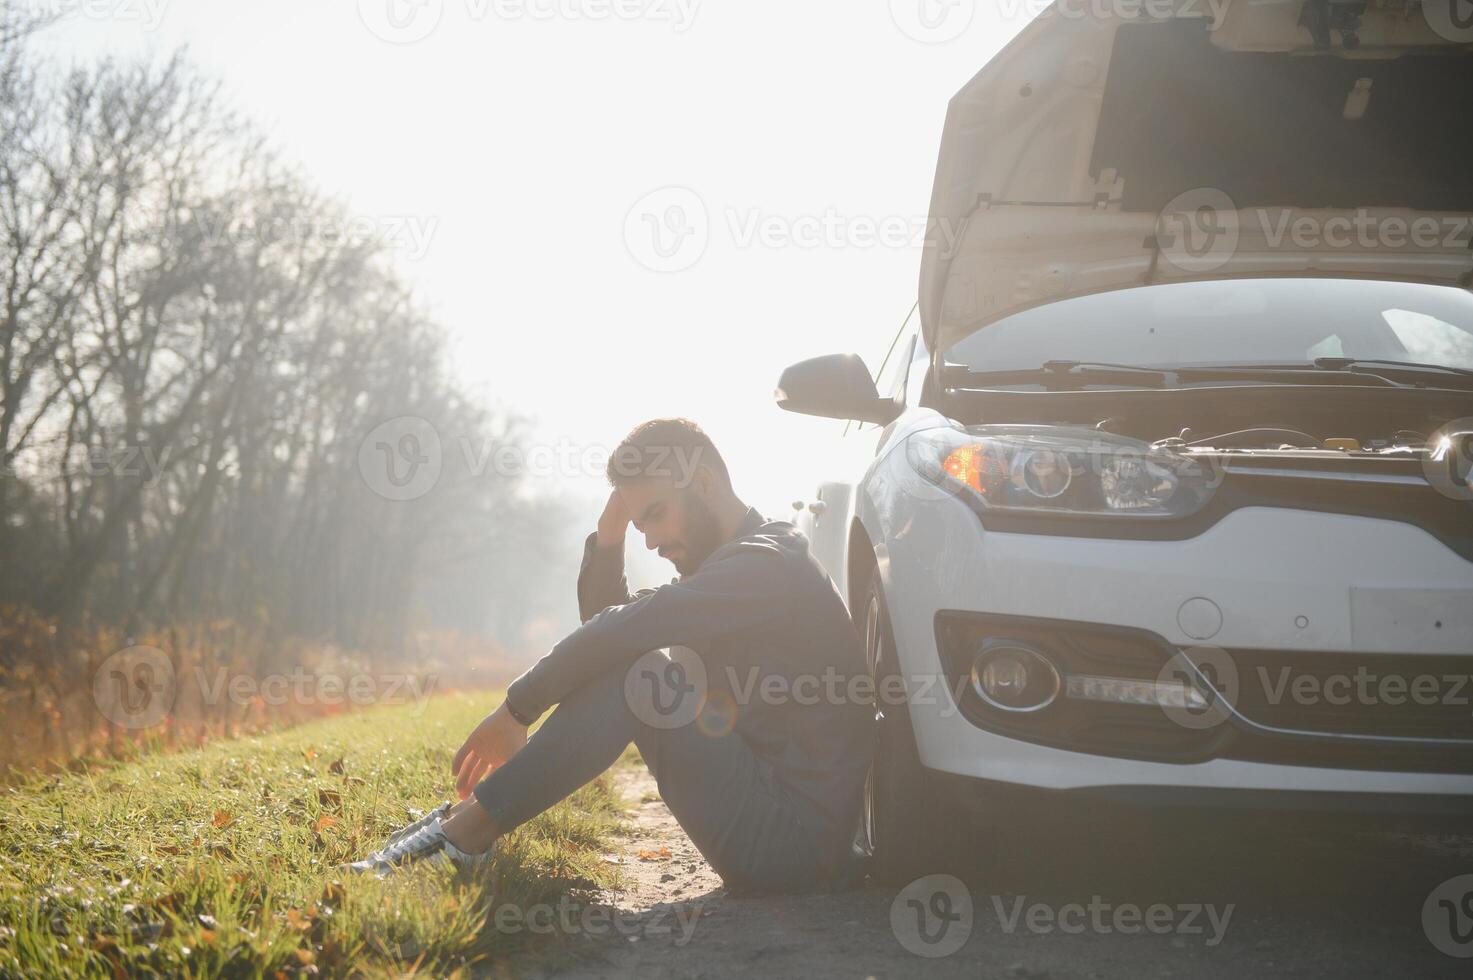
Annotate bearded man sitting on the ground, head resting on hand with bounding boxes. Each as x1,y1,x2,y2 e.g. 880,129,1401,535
352,419,873,893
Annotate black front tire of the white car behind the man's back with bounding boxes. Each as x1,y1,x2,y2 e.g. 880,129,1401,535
859,575,977,886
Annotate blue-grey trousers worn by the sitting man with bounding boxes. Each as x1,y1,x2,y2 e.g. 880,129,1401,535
474,657,820,893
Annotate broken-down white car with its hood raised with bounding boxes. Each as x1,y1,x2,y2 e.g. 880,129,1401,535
776,0,1473,878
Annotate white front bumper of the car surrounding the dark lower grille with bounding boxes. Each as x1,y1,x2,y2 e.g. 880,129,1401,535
881,501,1473,803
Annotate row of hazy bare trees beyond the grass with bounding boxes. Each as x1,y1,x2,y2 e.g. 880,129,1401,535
0,28,576,651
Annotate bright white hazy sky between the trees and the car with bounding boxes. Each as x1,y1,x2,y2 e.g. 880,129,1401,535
43,0,1037,542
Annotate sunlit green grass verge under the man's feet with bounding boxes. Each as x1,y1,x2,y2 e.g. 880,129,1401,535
0,694,639,977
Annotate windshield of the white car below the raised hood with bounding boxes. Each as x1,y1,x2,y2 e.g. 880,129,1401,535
946,279,1473,371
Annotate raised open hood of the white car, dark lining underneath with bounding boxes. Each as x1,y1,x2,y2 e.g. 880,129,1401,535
921,0,1473,351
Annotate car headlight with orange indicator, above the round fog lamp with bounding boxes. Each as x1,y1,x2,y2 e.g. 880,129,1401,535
906,426,1217,517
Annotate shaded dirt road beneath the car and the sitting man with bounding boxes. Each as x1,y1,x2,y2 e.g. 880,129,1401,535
488,768,1473,980
